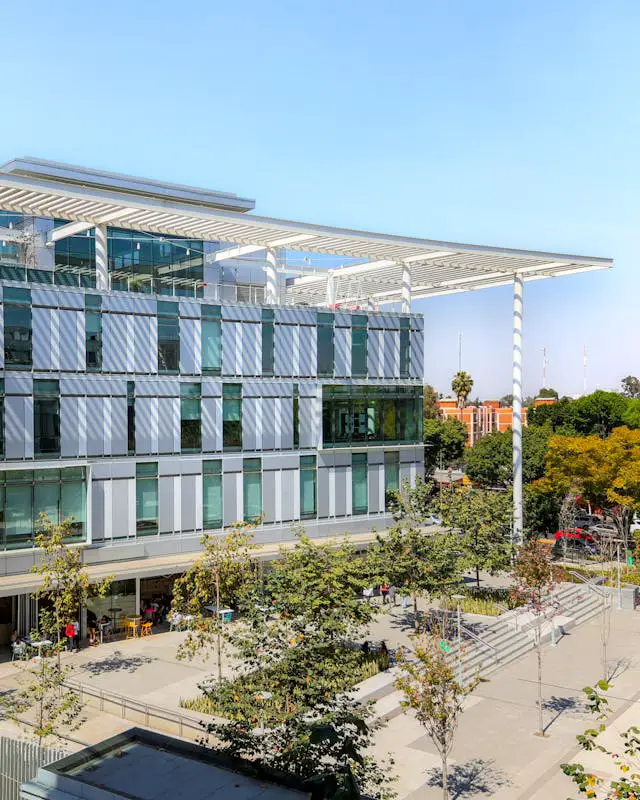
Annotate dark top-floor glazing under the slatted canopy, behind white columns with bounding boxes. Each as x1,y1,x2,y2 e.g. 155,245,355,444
107,228,204,297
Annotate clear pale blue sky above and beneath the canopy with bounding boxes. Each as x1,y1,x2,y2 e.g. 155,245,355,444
0,0,640,397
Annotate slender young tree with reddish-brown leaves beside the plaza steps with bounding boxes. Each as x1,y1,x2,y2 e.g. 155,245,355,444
513,539,555,736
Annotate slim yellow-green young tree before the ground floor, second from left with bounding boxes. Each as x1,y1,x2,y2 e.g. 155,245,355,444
171,525,256,682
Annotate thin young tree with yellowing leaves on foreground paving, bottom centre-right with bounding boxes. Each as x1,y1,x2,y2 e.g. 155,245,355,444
395,635,476,800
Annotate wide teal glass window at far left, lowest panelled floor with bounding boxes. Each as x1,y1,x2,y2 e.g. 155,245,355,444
0,467,87,550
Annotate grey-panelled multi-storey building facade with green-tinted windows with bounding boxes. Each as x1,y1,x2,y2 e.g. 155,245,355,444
0,161,423,629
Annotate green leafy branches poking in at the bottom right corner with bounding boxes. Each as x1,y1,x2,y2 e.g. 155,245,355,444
560,680,640,800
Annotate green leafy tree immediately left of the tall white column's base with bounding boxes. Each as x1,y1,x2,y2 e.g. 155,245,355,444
439,488,511,588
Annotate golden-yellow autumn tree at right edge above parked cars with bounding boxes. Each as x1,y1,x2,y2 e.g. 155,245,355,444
536,427,640,546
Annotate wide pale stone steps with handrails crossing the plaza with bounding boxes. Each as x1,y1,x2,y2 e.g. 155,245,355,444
356,583,604,720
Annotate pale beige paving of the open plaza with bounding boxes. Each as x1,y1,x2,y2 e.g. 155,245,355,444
0,592,640,800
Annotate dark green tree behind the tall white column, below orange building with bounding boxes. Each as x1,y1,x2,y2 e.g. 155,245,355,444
465,426,551,487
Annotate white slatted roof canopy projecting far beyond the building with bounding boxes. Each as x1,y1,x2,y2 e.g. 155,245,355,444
0,162,613,305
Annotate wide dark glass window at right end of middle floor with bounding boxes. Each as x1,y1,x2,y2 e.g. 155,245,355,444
322,385,422,447
